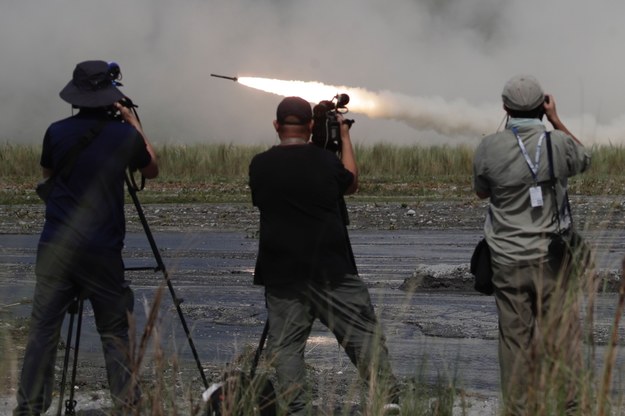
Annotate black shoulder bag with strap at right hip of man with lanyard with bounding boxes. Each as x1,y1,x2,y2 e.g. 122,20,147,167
546,132,592,273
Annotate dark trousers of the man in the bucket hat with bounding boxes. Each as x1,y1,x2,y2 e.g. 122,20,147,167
14,244,134,415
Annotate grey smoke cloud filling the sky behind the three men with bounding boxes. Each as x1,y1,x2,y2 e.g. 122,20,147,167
0,0,625,144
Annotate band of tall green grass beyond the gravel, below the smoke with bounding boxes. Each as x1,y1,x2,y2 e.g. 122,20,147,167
0,143,625,204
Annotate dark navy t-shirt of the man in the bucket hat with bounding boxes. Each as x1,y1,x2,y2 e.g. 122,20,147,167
40,112,151,253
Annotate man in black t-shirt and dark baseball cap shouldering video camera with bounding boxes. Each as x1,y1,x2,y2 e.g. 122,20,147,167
249,97,399,415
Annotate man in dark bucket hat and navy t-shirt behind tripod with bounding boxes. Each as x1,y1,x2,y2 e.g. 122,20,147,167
13,61,158,416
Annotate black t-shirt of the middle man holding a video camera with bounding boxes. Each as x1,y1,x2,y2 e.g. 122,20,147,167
249,144,357,285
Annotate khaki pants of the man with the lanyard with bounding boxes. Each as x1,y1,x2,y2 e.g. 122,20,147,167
493,262,582,415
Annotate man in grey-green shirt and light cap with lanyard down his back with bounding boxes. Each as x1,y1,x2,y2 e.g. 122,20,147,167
473,75,590,415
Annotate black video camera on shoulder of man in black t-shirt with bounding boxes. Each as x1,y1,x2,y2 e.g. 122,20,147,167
312,94,354,153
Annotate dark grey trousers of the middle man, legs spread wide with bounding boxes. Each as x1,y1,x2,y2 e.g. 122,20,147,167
265,275,397,415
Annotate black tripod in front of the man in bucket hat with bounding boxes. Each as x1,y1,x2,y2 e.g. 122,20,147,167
57,172,208,416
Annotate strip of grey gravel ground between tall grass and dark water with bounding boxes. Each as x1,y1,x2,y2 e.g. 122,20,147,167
0,196,625,234
